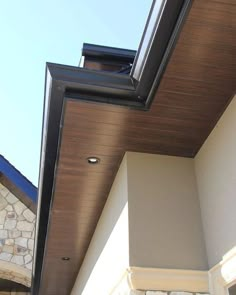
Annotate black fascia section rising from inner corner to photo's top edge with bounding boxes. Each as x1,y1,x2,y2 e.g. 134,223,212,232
131,0,193,98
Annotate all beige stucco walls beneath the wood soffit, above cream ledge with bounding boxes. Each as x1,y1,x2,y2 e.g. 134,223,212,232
72,98,236,295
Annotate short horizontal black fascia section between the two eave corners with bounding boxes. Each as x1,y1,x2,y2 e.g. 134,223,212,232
47,63,145,109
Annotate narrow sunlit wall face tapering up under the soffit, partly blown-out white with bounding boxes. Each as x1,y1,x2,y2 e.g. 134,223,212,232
71,158,129,295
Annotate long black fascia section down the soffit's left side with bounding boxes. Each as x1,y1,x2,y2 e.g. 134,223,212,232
31,66,67,295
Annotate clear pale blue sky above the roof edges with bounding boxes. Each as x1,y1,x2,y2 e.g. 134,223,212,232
0,0,152,185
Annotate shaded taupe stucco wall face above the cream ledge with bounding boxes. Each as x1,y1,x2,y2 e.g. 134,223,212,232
127,153,208,270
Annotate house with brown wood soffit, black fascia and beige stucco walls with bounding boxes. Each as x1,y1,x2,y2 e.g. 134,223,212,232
32,0,236,295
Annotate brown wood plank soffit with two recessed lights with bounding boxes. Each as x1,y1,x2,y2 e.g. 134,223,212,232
40,0,236,295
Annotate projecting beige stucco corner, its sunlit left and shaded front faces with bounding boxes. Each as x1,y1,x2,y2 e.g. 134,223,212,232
71,153,208,295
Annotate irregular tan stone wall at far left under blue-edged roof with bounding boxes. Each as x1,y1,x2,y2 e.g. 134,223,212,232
0,183,36,276
